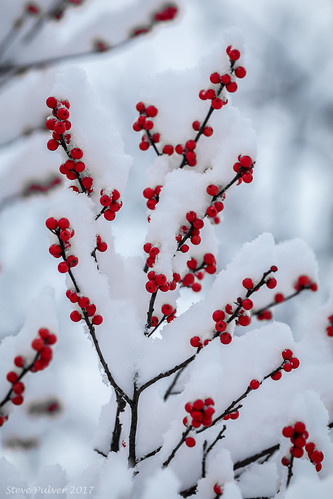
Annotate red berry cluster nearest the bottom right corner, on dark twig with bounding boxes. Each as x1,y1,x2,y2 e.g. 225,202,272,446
281,421,324,472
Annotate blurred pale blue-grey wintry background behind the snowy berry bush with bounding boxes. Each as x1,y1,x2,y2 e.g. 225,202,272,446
0,0,333,486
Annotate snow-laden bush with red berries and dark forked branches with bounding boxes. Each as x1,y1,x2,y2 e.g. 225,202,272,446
0,2,333,499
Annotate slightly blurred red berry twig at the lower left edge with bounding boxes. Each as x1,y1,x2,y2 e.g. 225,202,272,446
0,327,57,426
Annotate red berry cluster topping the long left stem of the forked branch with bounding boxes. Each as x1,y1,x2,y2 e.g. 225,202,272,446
45,217,79,274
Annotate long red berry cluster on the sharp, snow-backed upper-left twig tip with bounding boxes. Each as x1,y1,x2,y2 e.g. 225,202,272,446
46,97,93,195
